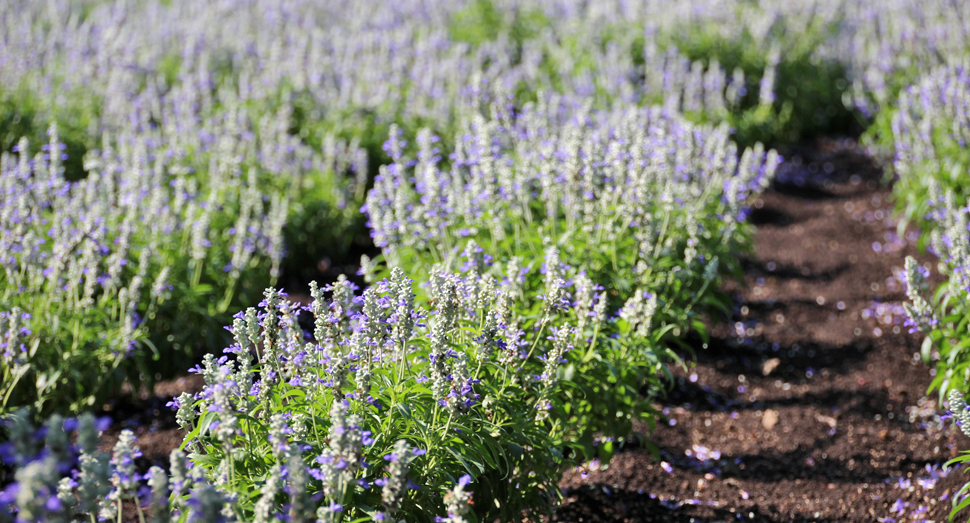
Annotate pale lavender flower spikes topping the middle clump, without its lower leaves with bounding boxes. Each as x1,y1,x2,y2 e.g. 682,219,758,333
365,103,778,263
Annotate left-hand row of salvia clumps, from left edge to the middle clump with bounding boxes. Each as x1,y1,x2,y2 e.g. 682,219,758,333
0,73,367,411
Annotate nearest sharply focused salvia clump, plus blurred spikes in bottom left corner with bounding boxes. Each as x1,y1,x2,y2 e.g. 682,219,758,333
0,251,649,523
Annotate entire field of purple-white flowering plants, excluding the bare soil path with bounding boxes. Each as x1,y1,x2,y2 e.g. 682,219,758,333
0,0,970,523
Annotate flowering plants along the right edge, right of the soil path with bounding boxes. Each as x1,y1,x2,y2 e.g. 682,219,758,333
891,61,970,514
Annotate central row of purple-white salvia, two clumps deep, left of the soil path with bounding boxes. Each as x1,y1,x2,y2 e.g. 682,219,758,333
5,100,776,522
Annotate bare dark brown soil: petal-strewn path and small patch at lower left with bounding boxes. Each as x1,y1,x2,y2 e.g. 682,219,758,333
96,140,970,523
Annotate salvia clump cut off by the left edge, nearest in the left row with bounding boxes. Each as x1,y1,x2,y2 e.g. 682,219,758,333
0,128,169,412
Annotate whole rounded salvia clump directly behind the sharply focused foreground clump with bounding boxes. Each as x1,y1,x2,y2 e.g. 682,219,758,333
365,97,779,327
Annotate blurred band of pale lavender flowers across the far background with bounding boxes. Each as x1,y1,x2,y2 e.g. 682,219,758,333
0,0,970,166
